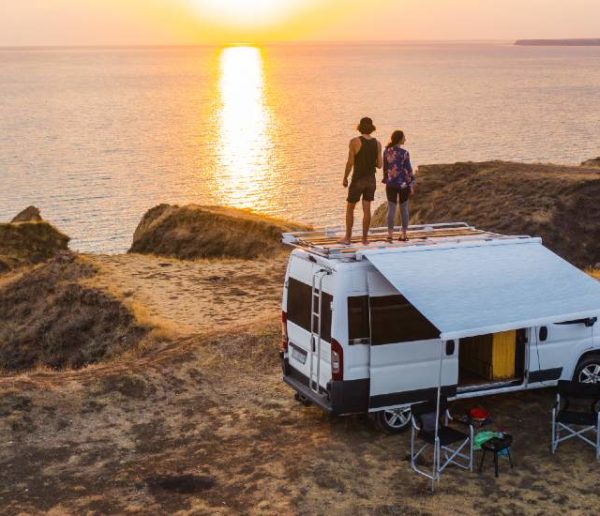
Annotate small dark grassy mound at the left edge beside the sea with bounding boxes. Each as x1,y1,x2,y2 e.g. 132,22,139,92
0,221,69,273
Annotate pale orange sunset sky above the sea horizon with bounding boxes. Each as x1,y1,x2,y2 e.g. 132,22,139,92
0,0,600,46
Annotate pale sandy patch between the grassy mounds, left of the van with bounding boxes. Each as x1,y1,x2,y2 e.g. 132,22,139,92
84,253,287,333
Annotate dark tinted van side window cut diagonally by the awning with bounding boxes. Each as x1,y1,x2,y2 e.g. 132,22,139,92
371,295,440,345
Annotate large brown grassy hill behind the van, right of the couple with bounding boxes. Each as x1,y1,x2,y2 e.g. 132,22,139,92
373,161,600,267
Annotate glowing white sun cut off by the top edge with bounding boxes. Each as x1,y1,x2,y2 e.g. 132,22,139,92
190,0,309,28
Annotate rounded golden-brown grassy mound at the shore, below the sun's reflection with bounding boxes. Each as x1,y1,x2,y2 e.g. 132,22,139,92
130,204,306,260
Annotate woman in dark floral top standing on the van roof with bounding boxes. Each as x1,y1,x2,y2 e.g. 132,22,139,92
383,131,416,242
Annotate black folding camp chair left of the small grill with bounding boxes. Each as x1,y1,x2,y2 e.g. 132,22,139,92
410,397,474,487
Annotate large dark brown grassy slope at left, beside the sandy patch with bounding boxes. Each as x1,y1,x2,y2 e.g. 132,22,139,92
0,253,147,371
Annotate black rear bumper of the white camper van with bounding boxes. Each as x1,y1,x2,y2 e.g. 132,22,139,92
282,357,369,416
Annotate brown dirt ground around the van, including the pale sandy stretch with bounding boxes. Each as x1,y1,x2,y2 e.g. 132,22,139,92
0,255,600,515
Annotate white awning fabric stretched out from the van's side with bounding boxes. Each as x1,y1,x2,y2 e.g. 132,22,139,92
361,238,600,340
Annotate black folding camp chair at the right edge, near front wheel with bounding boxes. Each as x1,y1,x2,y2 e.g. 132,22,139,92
552,380,600,459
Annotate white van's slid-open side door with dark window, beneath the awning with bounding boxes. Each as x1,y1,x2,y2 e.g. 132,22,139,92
368,272,458,411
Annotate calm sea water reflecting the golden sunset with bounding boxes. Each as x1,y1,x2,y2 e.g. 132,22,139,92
0,43,600,253
